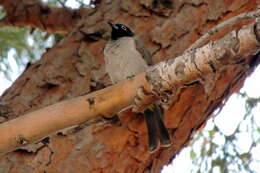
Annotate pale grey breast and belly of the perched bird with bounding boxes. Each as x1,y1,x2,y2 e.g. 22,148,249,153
104,37,149,83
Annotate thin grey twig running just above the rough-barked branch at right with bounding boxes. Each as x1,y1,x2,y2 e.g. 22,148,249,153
186,9,260,51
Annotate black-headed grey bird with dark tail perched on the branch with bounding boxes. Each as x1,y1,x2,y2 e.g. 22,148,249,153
104,21,172,153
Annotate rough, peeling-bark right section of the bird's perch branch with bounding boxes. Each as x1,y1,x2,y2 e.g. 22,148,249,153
147,23,260,93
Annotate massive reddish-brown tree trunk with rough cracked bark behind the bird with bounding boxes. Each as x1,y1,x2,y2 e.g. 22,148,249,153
0,0,259,173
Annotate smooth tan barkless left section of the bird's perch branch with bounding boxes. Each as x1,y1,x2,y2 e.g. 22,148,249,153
0,74,149,154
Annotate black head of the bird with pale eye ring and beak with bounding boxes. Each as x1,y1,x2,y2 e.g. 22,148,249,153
108,22,134,40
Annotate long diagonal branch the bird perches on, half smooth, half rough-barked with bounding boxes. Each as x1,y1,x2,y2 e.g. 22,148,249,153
0,16,260,153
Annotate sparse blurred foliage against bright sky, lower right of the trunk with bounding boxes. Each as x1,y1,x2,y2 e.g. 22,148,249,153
190,93,260,173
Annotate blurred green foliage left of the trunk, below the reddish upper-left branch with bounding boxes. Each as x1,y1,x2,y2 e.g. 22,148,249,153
0,27,53,79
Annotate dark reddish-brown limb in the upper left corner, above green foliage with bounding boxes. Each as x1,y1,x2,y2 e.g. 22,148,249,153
0,0,92,34
